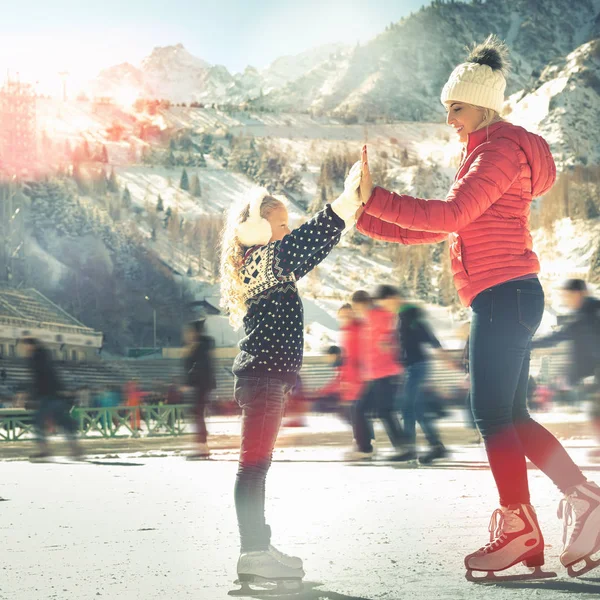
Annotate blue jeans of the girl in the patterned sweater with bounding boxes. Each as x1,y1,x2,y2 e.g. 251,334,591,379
234,377,292,552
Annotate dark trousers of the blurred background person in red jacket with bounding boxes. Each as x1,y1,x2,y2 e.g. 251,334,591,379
352,377,404,452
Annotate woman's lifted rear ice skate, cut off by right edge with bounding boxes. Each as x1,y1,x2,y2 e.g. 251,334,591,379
558,482,600,577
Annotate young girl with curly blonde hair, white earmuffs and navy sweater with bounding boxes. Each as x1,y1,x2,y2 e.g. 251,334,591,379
221,163,361,582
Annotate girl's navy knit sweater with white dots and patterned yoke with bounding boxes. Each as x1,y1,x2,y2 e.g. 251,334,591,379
233,205,345,384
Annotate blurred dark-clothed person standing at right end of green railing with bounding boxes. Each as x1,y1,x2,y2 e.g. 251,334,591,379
183,320,217,458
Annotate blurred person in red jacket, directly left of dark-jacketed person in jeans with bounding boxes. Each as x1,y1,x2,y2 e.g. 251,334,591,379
347,285,405,460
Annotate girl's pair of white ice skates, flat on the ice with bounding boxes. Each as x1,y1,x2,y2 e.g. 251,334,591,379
229,546,304,596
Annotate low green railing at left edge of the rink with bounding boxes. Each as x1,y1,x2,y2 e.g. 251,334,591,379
0,404,194,442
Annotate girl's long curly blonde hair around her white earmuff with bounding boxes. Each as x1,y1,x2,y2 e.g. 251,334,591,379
220,196,285,330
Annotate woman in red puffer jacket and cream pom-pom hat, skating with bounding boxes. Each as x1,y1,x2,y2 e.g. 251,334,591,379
358,36,600,574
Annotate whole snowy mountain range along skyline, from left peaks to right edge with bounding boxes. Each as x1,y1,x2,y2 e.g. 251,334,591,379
90,0,600,134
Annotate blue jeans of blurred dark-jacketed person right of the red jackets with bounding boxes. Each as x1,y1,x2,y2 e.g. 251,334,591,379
402,360,441,446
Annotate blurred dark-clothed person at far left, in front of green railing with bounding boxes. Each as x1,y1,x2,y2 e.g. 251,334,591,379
20,337,82,460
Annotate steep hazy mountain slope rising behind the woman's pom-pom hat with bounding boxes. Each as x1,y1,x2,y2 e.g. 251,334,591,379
254,0,600,120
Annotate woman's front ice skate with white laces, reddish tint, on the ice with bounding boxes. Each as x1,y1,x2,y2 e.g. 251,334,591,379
465,504,556,583
